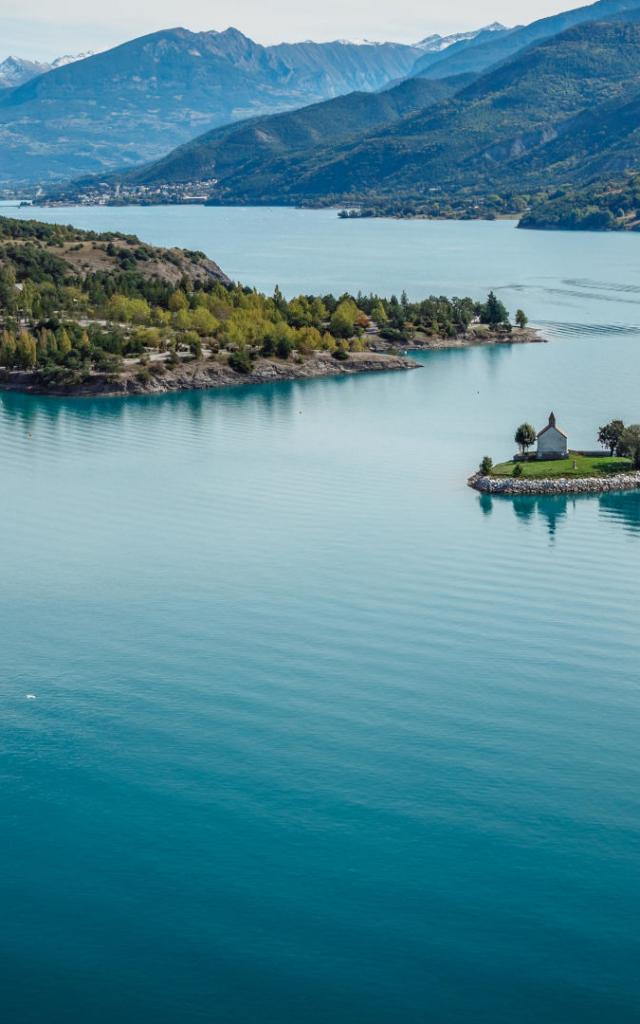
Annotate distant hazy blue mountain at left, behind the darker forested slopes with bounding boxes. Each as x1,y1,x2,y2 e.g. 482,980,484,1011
0,29,420,181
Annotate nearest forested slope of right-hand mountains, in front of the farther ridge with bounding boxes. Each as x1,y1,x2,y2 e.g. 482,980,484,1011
182,20,640,203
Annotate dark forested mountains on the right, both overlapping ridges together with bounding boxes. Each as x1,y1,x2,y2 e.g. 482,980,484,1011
99,0,640,211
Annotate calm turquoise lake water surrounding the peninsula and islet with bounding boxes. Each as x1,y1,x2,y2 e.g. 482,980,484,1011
0,208,640,1024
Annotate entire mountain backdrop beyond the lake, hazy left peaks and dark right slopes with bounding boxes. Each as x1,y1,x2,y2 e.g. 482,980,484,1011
0,0,640,223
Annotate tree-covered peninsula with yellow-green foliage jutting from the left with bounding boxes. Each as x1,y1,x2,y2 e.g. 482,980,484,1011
0,218,539,395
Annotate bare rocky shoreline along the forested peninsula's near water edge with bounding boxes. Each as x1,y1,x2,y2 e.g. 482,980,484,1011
0,351,420,397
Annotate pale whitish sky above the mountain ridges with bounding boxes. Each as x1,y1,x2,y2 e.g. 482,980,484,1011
0,0,589,60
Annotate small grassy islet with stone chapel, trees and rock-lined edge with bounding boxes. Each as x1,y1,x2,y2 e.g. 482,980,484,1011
468,413,640,495
